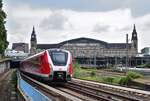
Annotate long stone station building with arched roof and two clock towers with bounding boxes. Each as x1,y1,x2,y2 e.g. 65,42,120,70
30,25,138,66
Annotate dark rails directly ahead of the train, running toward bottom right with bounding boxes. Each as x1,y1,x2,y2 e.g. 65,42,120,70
62,82,137,101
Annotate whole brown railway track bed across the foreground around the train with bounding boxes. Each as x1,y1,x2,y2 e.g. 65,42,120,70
19,72,150,101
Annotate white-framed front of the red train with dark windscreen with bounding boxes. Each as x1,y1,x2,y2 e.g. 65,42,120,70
48,49,72,81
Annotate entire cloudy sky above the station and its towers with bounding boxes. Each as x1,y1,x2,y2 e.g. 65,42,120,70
3,0,150,51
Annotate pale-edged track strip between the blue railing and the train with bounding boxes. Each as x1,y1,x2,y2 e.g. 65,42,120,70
21,74,111,101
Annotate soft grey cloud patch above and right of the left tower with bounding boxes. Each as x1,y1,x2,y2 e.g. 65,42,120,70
40,12,68,30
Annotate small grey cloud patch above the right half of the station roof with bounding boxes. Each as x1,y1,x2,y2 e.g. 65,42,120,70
93,24,110,33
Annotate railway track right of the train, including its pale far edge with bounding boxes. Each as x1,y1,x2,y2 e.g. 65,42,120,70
69,79,150,101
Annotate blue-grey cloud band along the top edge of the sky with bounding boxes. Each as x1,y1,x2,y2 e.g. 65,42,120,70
7,0,150,16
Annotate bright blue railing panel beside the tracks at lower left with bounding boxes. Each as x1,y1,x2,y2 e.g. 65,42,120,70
17,72,52,101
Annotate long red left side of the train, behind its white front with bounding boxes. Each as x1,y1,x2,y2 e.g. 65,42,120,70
21,51,50,78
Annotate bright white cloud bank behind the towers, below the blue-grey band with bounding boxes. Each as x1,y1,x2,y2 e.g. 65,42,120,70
4,5,150,49
